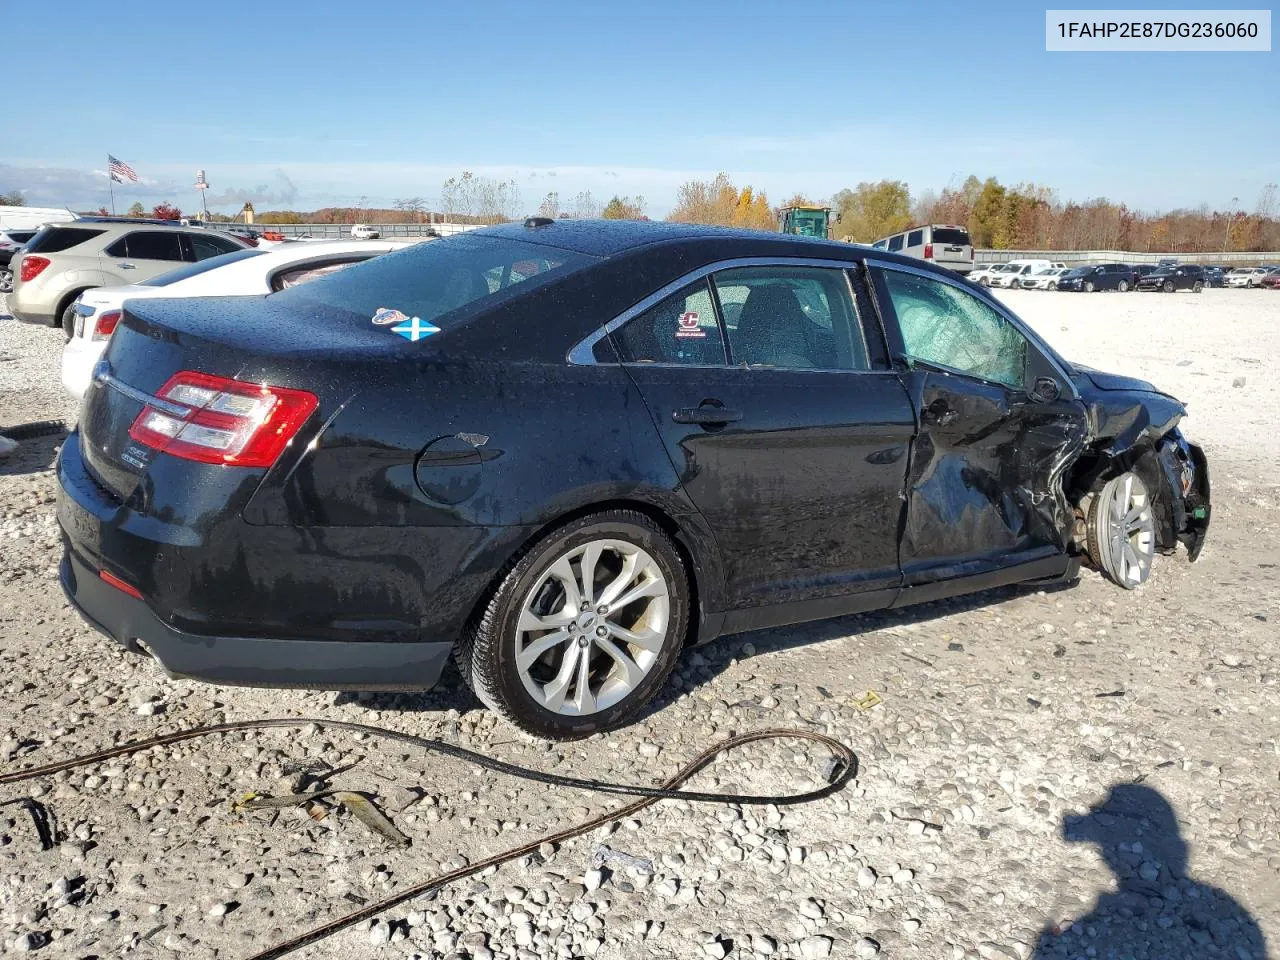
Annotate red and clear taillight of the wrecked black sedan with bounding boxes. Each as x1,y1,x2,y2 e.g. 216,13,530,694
129,370,319,467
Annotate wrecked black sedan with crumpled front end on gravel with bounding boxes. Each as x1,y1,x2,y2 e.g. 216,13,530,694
58,219,1210,739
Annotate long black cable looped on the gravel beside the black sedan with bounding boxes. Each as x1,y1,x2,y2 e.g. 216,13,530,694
0,717,858,960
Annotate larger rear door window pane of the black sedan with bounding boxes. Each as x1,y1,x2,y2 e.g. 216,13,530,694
713,266,870,370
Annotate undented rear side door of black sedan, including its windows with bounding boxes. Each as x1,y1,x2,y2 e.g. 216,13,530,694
614,261,915,616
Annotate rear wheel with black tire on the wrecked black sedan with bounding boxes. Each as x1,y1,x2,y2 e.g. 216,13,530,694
457,511,690,740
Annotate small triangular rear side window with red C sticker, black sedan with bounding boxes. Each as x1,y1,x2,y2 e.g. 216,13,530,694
613,280,724,366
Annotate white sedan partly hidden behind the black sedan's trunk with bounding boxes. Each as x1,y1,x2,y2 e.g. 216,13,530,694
63,241,411,399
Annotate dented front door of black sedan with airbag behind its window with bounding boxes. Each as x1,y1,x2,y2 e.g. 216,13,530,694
873,264,1085,598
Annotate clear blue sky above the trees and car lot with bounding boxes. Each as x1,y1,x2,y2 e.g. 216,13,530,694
0,0,1280,216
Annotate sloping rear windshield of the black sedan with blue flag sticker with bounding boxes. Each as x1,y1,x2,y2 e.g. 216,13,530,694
271,234,598,328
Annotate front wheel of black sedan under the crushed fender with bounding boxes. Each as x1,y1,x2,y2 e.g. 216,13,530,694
1085,471,1156,590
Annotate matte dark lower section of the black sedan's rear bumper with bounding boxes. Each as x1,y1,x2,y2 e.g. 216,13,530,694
59,549,453,690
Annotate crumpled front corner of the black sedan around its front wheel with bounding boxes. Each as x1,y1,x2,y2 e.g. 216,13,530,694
1065,366,1211,586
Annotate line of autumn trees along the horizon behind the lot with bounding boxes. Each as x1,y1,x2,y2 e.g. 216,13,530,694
3,170,1280,252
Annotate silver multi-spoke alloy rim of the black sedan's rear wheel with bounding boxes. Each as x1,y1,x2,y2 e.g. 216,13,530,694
516,539,671,716
